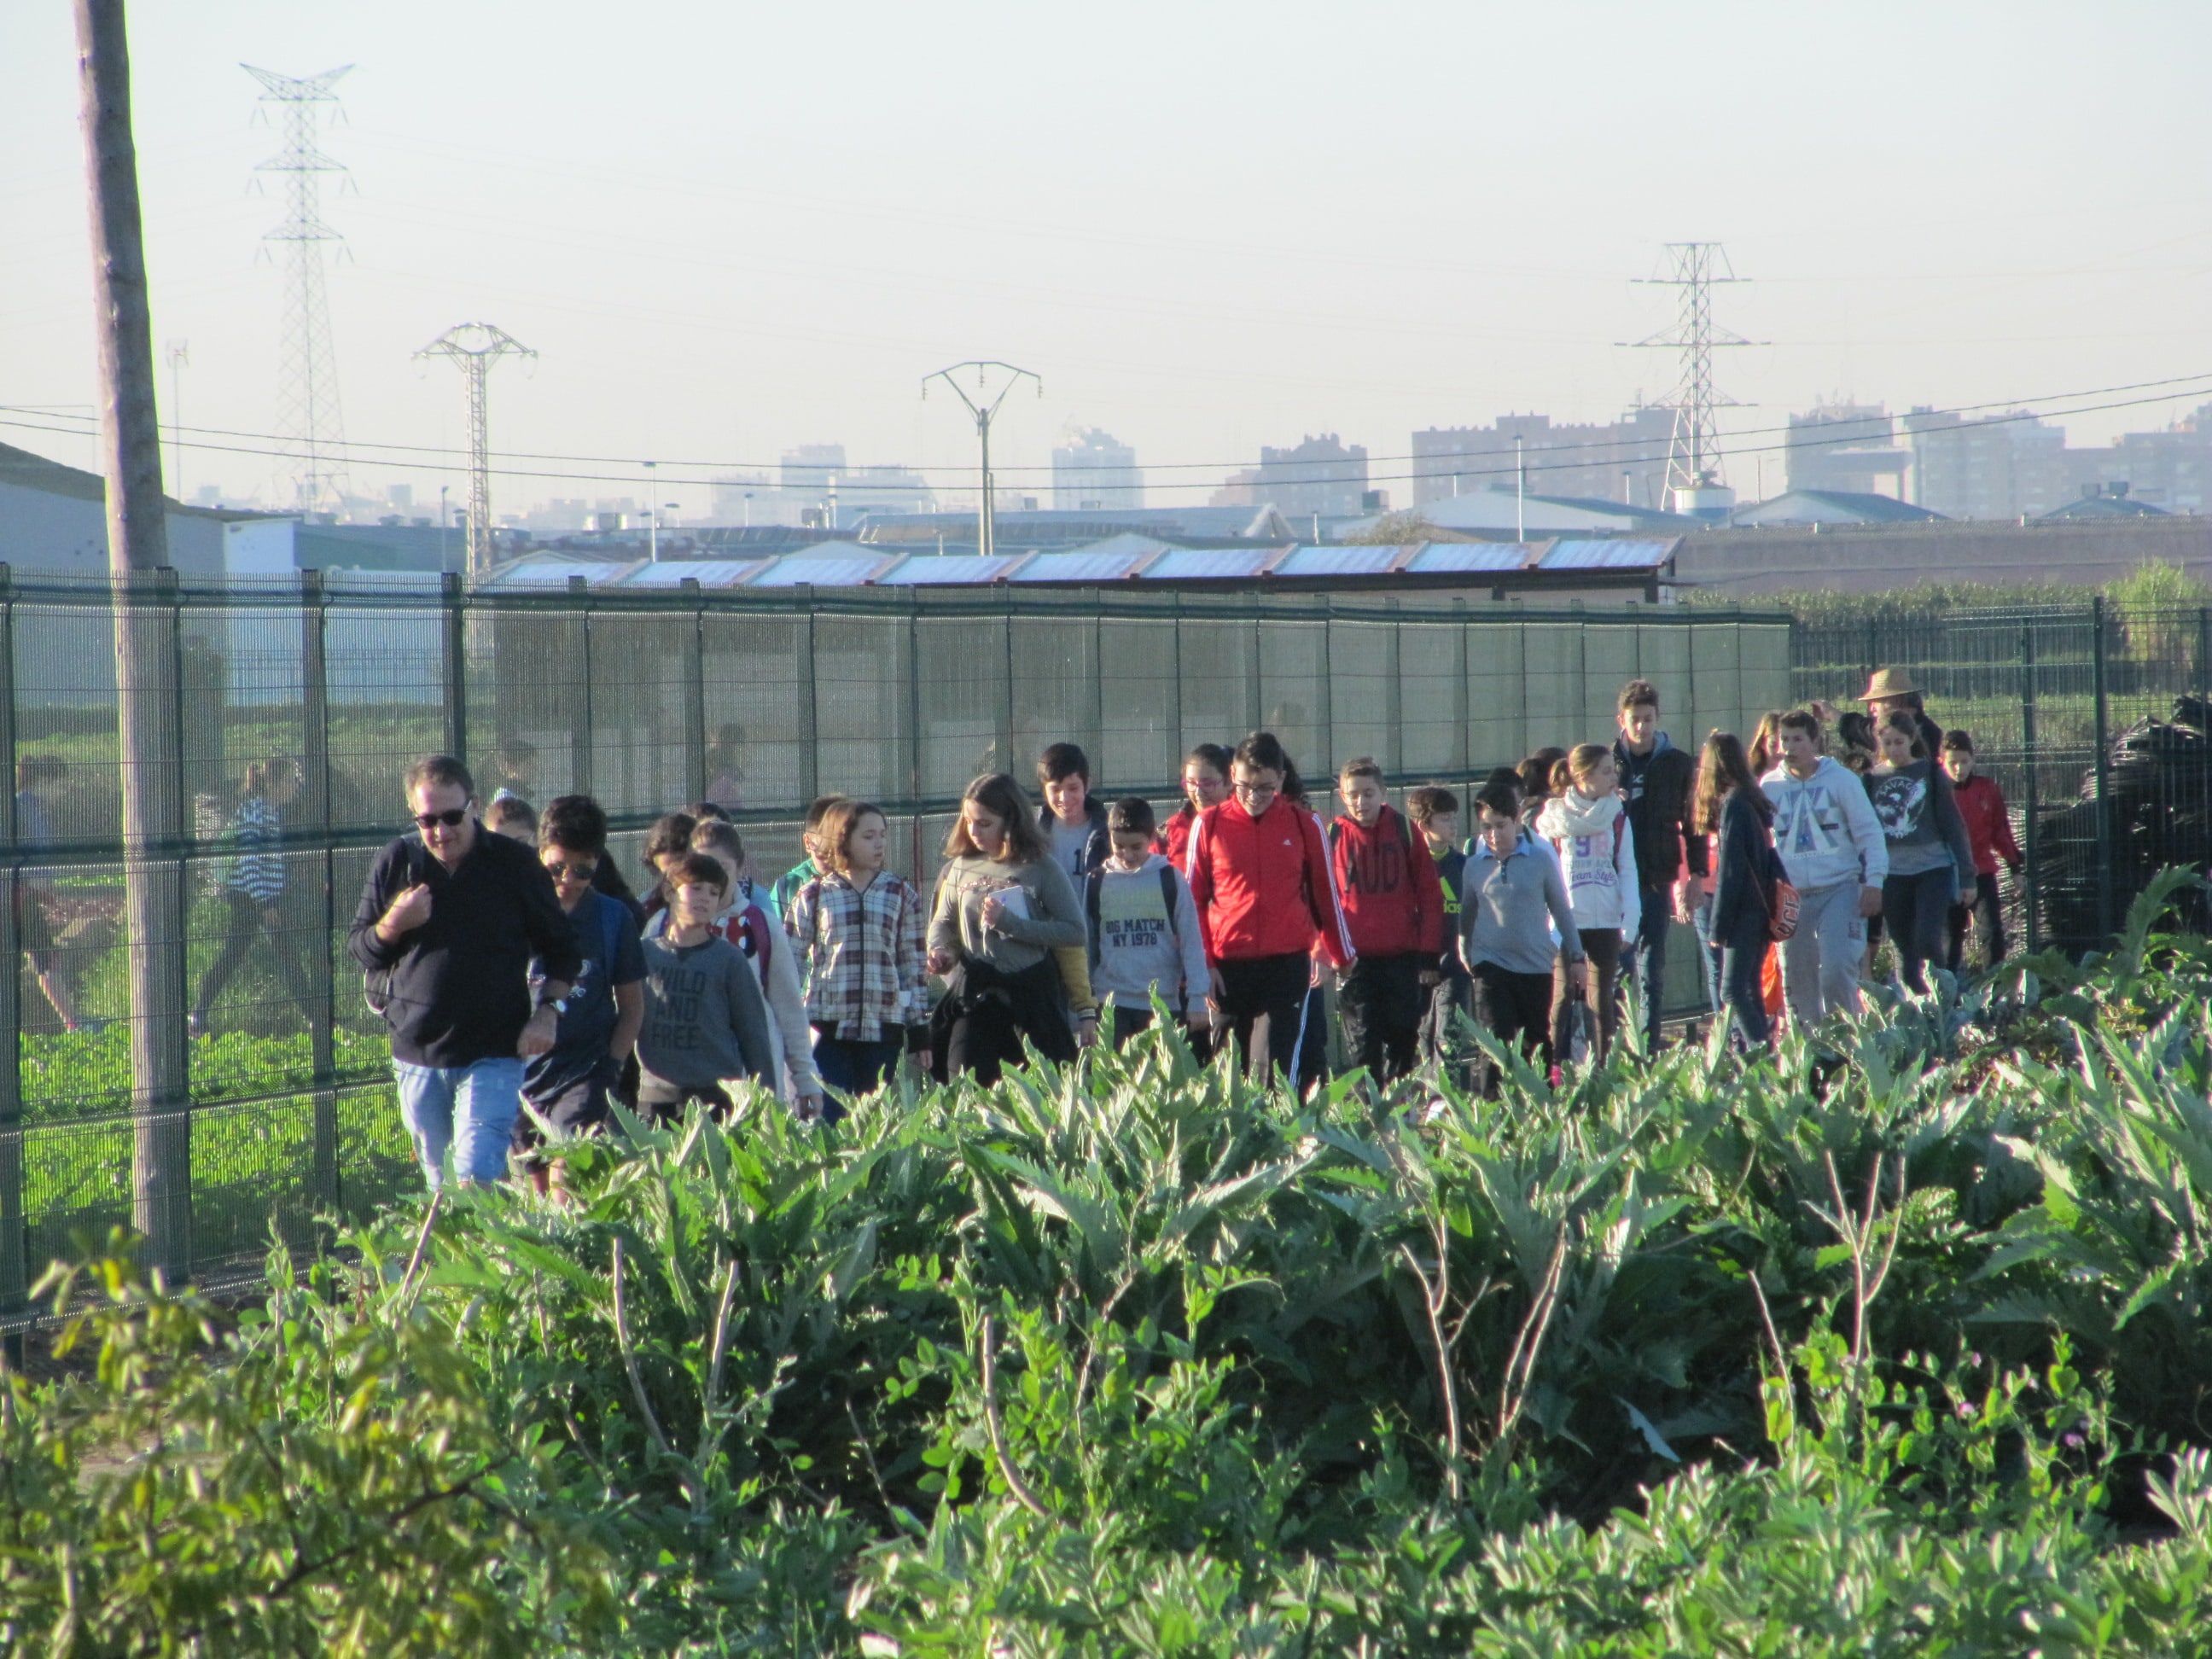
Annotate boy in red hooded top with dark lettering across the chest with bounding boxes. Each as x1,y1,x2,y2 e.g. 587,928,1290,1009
1330,756,1445,1084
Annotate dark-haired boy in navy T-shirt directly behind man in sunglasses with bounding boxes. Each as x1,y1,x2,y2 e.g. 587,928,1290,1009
513,796,646,1192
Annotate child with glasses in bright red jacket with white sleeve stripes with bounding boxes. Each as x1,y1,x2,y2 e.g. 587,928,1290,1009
1184,732,1356,1077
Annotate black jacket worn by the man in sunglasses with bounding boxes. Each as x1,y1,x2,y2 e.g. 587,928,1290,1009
345,825,584,1066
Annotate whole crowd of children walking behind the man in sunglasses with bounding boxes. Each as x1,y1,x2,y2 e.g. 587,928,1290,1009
466,677,2019,1144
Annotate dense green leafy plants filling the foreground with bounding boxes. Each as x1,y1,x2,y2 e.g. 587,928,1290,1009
0,878,2212,1655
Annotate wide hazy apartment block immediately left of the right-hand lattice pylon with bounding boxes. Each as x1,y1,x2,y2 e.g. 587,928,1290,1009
1413,410,1674,509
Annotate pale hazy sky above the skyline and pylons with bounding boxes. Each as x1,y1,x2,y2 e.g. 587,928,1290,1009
0,0,2212,511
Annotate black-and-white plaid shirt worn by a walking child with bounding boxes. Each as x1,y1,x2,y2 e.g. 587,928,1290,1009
783,870,929,1042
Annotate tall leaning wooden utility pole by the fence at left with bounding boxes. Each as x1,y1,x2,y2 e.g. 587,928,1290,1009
73,0,193,1281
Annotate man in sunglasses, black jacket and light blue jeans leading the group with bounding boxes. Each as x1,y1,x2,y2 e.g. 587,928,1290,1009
347,754,582,1190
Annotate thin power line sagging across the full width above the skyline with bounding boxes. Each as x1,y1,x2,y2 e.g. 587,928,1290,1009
0,370,2212,489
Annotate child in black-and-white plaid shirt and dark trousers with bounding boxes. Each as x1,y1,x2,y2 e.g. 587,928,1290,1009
783,800,929,1121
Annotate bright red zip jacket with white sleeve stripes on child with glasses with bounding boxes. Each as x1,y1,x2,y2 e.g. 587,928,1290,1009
1184,796,1353,967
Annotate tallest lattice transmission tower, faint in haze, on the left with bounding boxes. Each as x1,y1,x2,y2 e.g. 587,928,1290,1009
239,64,352,513
